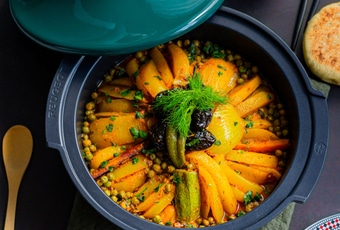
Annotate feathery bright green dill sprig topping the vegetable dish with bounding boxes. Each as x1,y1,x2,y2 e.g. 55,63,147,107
153,74,227,137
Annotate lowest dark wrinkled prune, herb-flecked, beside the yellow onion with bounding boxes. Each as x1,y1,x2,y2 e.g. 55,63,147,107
185,129,216,151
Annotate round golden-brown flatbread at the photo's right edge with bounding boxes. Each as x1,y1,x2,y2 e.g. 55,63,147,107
302,2,340,85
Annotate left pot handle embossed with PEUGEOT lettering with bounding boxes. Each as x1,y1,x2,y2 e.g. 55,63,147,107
45,55,84,149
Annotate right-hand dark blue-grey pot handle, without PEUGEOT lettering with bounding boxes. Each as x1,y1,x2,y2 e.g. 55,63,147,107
291,88,329,203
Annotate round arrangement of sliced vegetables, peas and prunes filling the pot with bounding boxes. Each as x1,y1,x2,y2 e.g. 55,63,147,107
82,40,290,228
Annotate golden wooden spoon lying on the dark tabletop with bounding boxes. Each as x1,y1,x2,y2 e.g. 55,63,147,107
2,125,33,230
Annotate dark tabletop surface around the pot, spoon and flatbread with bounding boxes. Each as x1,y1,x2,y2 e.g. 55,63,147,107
0,0,340,230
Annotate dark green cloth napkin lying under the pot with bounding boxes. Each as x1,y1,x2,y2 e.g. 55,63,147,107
67,79,330,230
